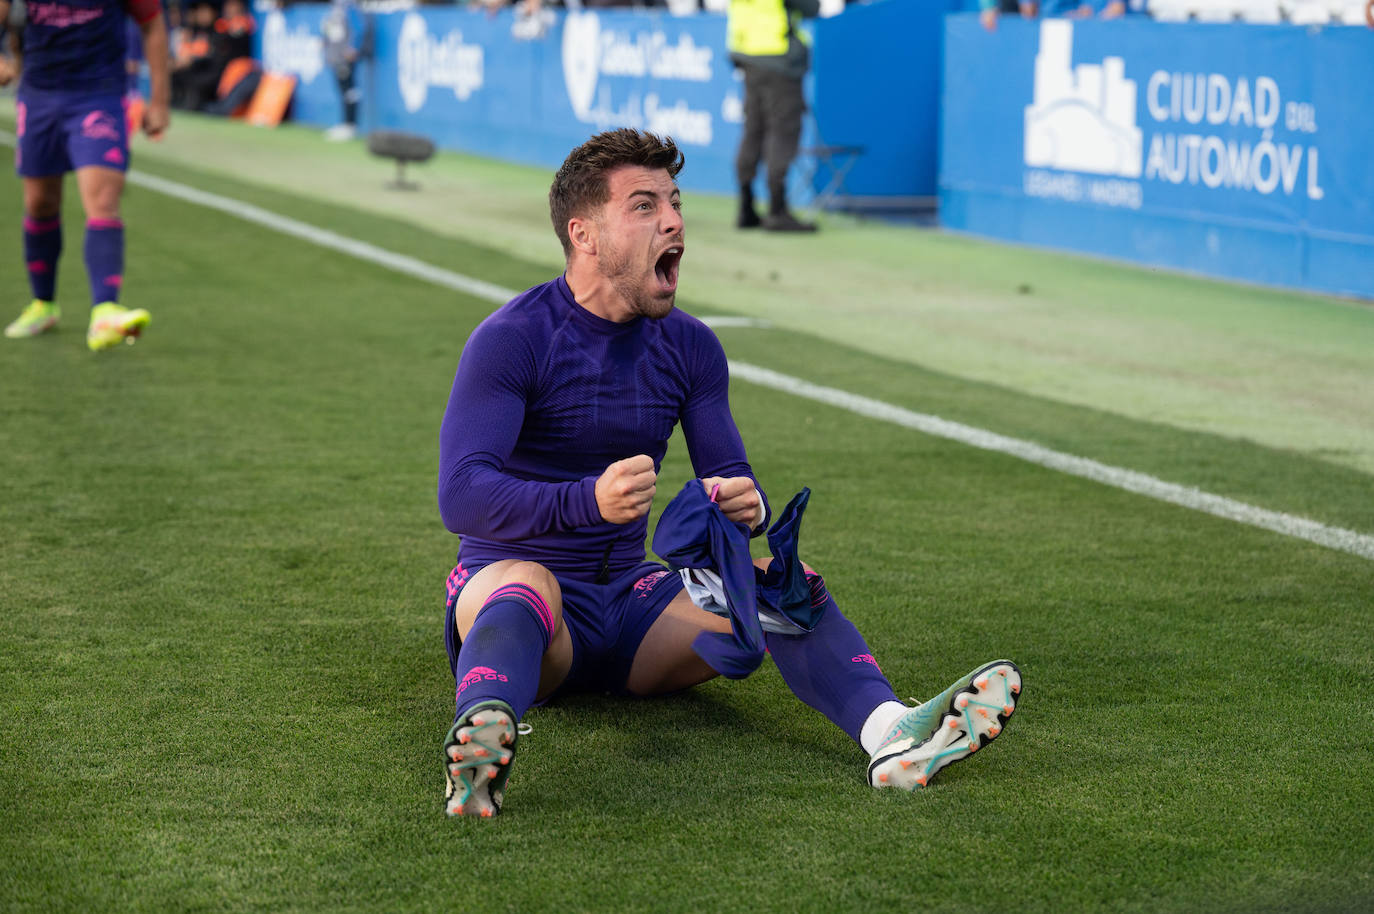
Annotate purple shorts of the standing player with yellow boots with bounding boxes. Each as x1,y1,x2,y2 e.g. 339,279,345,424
14,89,129,177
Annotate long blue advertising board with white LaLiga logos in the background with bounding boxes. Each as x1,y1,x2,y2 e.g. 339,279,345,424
260,4,743,192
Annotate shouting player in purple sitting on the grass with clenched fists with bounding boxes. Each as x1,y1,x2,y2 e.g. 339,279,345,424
438,129,1021,816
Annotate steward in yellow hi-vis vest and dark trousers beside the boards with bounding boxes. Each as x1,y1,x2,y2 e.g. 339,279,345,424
725,0,820,232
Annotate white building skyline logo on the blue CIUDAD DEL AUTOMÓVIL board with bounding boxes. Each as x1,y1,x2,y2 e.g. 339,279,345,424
1025,19,1143,177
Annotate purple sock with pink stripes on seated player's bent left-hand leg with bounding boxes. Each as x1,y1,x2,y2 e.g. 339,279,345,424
453,584,554,720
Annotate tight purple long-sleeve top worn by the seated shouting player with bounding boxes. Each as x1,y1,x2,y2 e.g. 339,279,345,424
438,276,763,581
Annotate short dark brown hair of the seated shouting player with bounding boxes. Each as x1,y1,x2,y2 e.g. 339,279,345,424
548,126,686,257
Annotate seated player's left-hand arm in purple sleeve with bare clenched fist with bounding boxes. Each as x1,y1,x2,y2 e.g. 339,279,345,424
438,319,612,542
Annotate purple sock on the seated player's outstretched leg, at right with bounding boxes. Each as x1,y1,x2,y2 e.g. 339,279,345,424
765,573,897,742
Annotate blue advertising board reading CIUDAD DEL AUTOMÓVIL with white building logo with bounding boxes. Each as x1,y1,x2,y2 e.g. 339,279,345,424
940,15,1374,297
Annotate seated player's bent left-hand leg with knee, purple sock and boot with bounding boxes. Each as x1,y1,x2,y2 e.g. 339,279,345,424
444,559,573,816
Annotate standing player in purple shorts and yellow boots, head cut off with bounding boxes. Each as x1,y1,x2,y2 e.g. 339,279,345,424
0,0,170,349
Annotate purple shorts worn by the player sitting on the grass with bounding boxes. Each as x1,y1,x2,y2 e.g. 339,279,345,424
444,562,683,695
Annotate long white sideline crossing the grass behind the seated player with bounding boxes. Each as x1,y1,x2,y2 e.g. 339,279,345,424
0,131,1357,559
